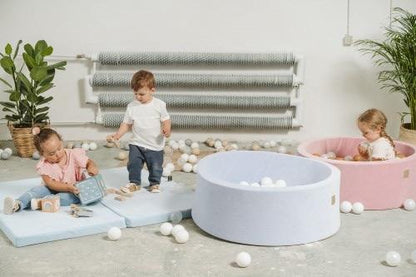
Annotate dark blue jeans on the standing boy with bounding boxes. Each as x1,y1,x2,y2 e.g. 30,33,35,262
127,144,163,185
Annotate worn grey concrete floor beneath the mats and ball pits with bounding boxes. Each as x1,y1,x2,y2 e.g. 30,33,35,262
0,141,416,277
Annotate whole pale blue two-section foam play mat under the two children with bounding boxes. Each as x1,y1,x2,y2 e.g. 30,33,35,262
0,167,193,247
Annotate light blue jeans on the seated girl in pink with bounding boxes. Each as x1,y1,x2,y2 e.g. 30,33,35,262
17,185,80,210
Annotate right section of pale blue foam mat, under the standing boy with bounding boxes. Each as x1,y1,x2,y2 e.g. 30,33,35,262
101,168,194,227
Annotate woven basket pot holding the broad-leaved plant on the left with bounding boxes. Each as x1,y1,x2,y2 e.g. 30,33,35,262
7,122,49,158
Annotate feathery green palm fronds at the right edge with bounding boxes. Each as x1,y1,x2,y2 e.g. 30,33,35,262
356,8,416,130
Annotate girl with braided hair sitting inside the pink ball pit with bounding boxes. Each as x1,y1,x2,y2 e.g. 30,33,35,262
354,109,396,161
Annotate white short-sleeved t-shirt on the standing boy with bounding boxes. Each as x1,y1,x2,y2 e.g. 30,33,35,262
123,97,170,151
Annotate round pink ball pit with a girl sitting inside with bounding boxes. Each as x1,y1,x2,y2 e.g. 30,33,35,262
297,137,416,210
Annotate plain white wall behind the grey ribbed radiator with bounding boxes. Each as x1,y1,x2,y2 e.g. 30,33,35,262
0,0,416,140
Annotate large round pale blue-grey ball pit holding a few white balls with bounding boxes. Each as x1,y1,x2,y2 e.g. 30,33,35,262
192,151,340,246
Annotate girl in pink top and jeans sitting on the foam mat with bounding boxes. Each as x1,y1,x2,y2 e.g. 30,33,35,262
3,127,98,214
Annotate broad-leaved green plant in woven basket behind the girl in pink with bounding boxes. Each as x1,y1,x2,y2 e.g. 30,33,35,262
0,40,66,157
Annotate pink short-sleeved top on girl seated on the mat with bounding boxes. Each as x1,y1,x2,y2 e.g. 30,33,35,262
36,148,88,183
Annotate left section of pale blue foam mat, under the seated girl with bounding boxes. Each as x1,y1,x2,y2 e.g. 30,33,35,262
0,178,125,247
